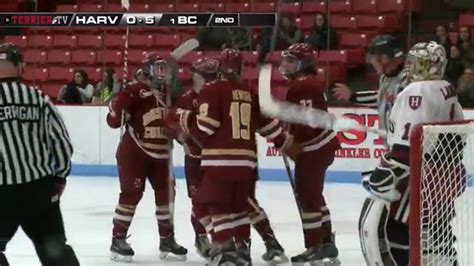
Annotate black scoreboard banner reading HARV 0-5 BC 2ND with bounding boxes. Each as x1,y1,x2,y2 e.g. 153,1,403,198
0,13,276,28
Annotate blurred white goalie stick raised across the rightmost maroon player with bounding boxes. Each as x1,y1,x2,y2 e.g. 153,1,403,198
258,64,387,136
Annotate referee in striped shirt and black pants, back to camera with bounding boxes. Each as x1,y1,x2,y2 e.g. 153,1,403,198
0,44,79,266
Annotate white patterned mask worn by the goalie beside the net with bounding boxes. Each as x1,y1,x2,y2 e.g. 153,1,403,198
405,42,448,82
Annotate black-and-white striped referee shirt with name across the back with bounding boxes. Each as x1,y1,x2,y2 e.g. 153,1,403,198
0,78,73,185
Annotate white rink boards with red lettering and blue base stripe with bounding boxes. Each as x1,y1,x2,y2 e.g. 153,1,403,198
62,106,474,183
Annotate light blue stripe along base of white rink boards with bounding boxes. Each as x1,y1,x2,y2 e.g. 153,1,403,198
72,164,361,184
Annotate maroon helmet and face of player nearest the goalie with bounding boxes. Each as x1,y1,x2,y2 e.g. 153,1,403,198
278,43,315,78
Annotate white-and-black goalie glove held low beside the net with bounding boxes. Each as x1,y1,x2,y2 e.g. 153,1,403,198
362,153,410,202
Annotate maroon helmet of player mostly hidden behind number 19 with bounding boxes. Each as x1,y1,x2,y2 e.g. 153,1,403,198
191,57,219,92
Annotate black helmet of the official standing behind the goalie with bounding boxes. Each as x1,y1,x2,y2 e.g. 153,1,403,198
367,34,404,58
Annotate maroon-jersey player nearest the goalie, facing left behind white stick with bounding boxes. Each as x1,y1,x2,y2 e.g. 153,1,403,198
280,43,340,264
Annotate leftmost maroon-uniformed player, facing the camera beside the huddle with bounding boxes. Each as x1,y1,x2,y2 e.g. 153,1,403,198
107,53,187,261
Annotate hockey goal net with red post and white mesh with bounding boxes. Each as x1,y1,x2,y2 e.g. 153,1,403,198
409,120,474,266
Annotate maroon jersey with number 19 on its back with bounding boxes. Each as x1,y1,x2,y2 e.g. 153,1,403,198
184,81,286,175
